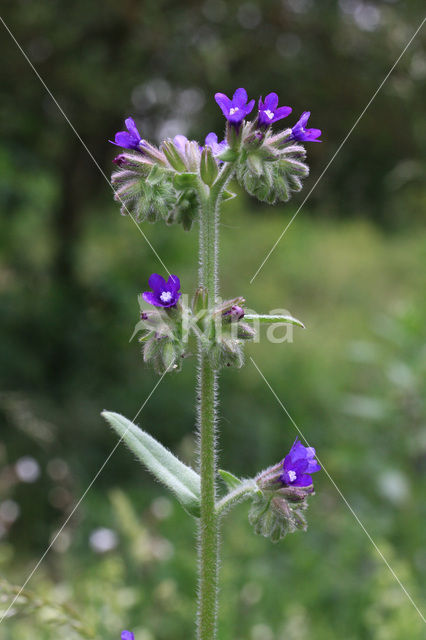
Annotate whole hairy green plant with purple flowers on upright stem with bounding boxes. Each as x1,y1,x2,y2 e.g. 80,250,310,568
103,88,321,640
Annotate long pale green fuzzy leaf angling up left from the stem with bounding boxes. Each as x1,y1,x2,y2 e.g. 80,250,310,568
102,411,201,517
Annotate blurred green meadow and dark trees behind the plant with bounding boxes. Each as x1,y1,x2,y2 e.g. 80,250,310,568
0,0,426,640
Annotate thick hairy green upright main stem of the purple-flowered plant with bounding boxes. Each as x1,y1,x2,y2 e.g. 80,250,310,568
197,164,233,640
